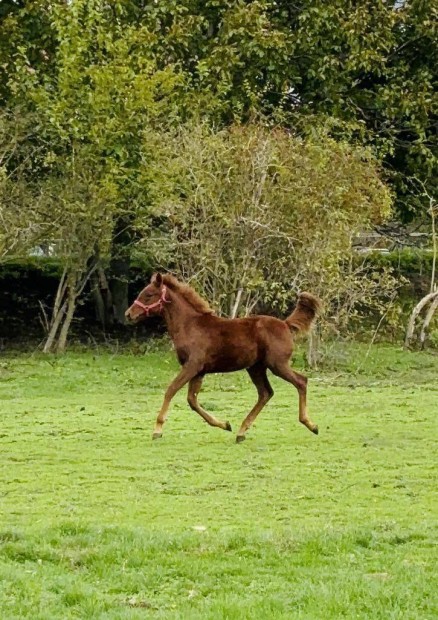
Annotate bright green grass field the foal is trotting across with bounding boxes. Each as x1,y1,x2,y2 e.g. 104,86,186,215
0,345,438,620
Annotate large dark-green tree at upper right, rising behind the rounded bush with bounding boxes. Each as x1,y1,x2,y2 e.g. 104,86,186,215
115,0,438,219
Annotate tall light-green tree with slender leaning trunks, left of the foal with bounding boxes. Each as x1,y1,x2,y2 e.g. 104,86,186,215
1,0,180,350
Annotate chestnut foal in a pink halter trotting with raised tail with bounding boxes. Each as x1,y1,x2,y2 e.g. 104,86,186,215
126,273,320,443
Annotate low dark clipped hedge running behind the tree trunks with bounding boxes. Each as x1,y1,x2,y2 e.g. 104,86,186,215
0,249,432,346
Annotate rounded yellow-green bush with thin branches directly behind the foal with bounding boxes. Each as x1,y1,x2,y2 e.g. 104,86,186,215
145,124,394,324
